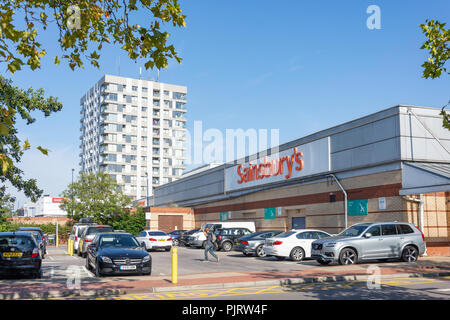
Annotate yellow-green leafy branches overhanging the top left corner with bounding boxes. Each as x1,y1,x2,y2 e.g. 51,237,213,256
0,0,185,73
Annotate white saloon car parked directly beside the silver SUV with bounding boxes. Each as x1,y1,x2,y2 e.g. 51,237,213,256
263,229,331,261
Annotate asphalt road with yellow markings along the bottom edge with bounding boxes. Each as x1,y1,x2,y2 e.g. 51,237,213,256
102,277,450,303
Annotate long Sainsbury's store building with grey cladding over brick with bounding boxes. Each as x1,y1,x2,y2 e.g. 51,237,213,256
154,105,450,255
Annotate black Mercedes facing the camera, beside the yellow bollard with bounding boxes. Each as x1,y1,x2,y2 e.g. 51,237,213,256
86,232,152,277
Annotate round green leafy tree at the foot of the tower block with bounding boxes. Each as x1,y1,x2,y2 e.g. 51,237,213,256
60,172,131,224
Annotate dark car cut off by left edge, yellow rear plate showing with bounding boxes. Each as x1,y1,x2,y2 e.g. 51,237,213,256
0,231,42,278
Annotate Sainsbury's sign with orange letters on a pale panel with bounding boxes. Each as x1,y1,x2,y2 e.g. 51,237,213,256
225,137,330,191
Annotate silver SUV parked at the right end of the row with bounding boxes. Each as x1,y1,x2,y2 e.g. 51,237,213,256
311,222,426,265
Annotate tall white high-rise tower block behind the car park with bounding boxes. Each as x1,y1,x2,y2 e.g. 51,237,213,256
80,75,187,199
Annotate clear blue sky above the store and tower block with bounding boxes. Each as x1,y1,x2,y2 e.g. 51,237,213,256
4,0,450,205
